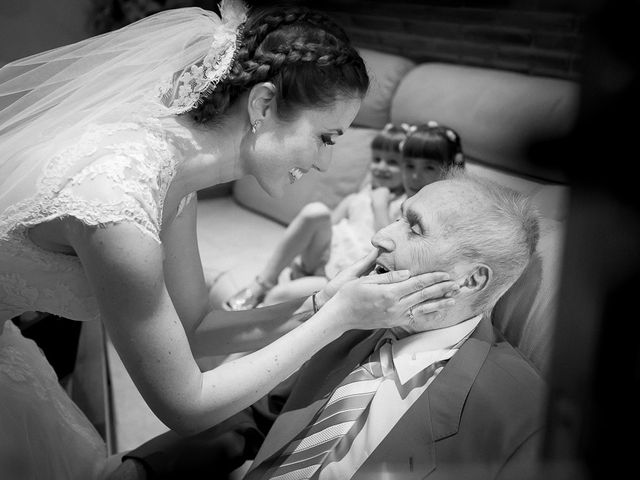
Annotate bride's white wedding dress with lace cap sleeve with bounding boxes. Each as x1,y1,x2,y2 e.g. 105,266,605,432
0,120,193,480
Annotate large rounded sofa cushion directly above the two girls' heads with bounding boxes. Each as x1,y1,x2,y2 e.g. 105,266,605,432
391,63,579,181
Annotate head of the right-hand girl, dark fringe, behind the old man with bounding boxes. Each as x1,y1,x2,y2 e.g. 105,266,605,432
402,121,464,197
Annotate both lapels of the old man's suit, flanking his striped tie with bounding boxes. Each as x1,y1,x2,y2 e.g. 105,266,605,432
254,318,494,480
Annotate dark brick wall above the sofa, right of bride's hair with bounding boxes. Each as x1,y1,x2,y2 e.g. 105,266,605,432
250,0,584,80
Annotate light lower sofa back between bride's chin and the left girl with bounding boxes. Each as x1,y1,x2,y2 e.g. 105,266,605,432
233,128,378,225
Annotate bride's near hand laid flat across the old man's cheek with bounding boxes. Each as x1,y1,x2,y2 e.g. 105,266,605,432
323,270,458,330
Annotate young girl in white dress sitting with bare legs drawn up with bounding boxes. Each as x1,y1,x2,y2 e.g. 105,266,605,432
225,124,405,310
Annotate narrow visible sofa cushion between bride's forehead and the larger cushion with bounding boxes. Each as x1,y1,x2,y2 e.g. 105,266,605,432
353,48,415,128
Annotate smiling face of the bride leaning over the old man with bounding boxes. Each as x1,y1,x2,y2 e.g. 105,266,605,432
243,99,361,197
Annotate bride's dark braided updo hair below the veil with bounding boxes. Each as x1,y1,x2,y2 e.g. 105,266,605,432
191,7,369,123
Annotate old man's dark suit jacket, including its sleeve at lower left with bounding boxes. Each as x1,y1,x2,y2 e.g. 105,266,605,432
125,319,546,480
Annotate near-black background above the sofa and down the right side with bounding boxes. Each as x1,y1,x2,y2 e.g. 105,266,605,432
20,0,640,479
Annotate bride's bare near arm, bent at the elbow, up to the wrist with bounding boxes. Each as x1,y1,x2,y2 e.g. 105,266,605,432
69,219,352,434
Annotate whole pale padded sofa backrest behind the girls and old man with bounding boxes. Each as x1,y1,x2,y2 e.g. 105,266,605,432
234,50,578,374
